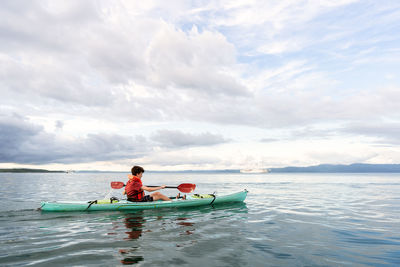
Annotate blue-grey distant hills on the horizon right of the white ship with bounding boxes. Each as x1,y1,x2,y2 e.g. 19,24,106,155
269,163,400,173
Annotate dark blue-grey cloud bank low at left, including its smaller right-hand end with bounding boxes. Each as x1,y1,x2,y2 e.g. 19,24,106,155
0,114,227,164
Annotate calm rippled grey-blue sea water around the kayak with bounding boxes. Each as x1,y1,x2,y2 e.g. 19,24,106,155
0,173,400,266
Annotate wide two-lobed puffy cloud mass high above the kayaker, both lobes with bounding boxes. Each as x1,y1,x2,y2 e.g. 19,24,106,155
86,18,249,96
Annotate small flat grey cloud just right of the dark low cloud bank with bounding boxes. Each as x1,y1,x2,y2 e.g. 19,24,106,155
151,130,228,148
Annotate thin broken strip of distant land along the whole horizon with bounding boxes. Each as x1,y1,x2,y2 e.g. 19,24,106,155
0,163,400,175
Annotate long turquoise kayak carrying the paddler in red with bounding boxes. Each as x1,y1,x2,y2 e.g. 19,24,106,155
40,190,248,214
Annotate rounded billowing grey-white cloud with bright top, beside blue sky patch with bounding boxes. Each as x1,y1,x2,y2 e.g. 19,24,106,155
147,25,249,96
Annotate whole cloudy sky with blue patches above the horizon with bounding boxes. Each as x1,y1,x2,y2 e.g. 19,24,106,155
0,0,400,171
